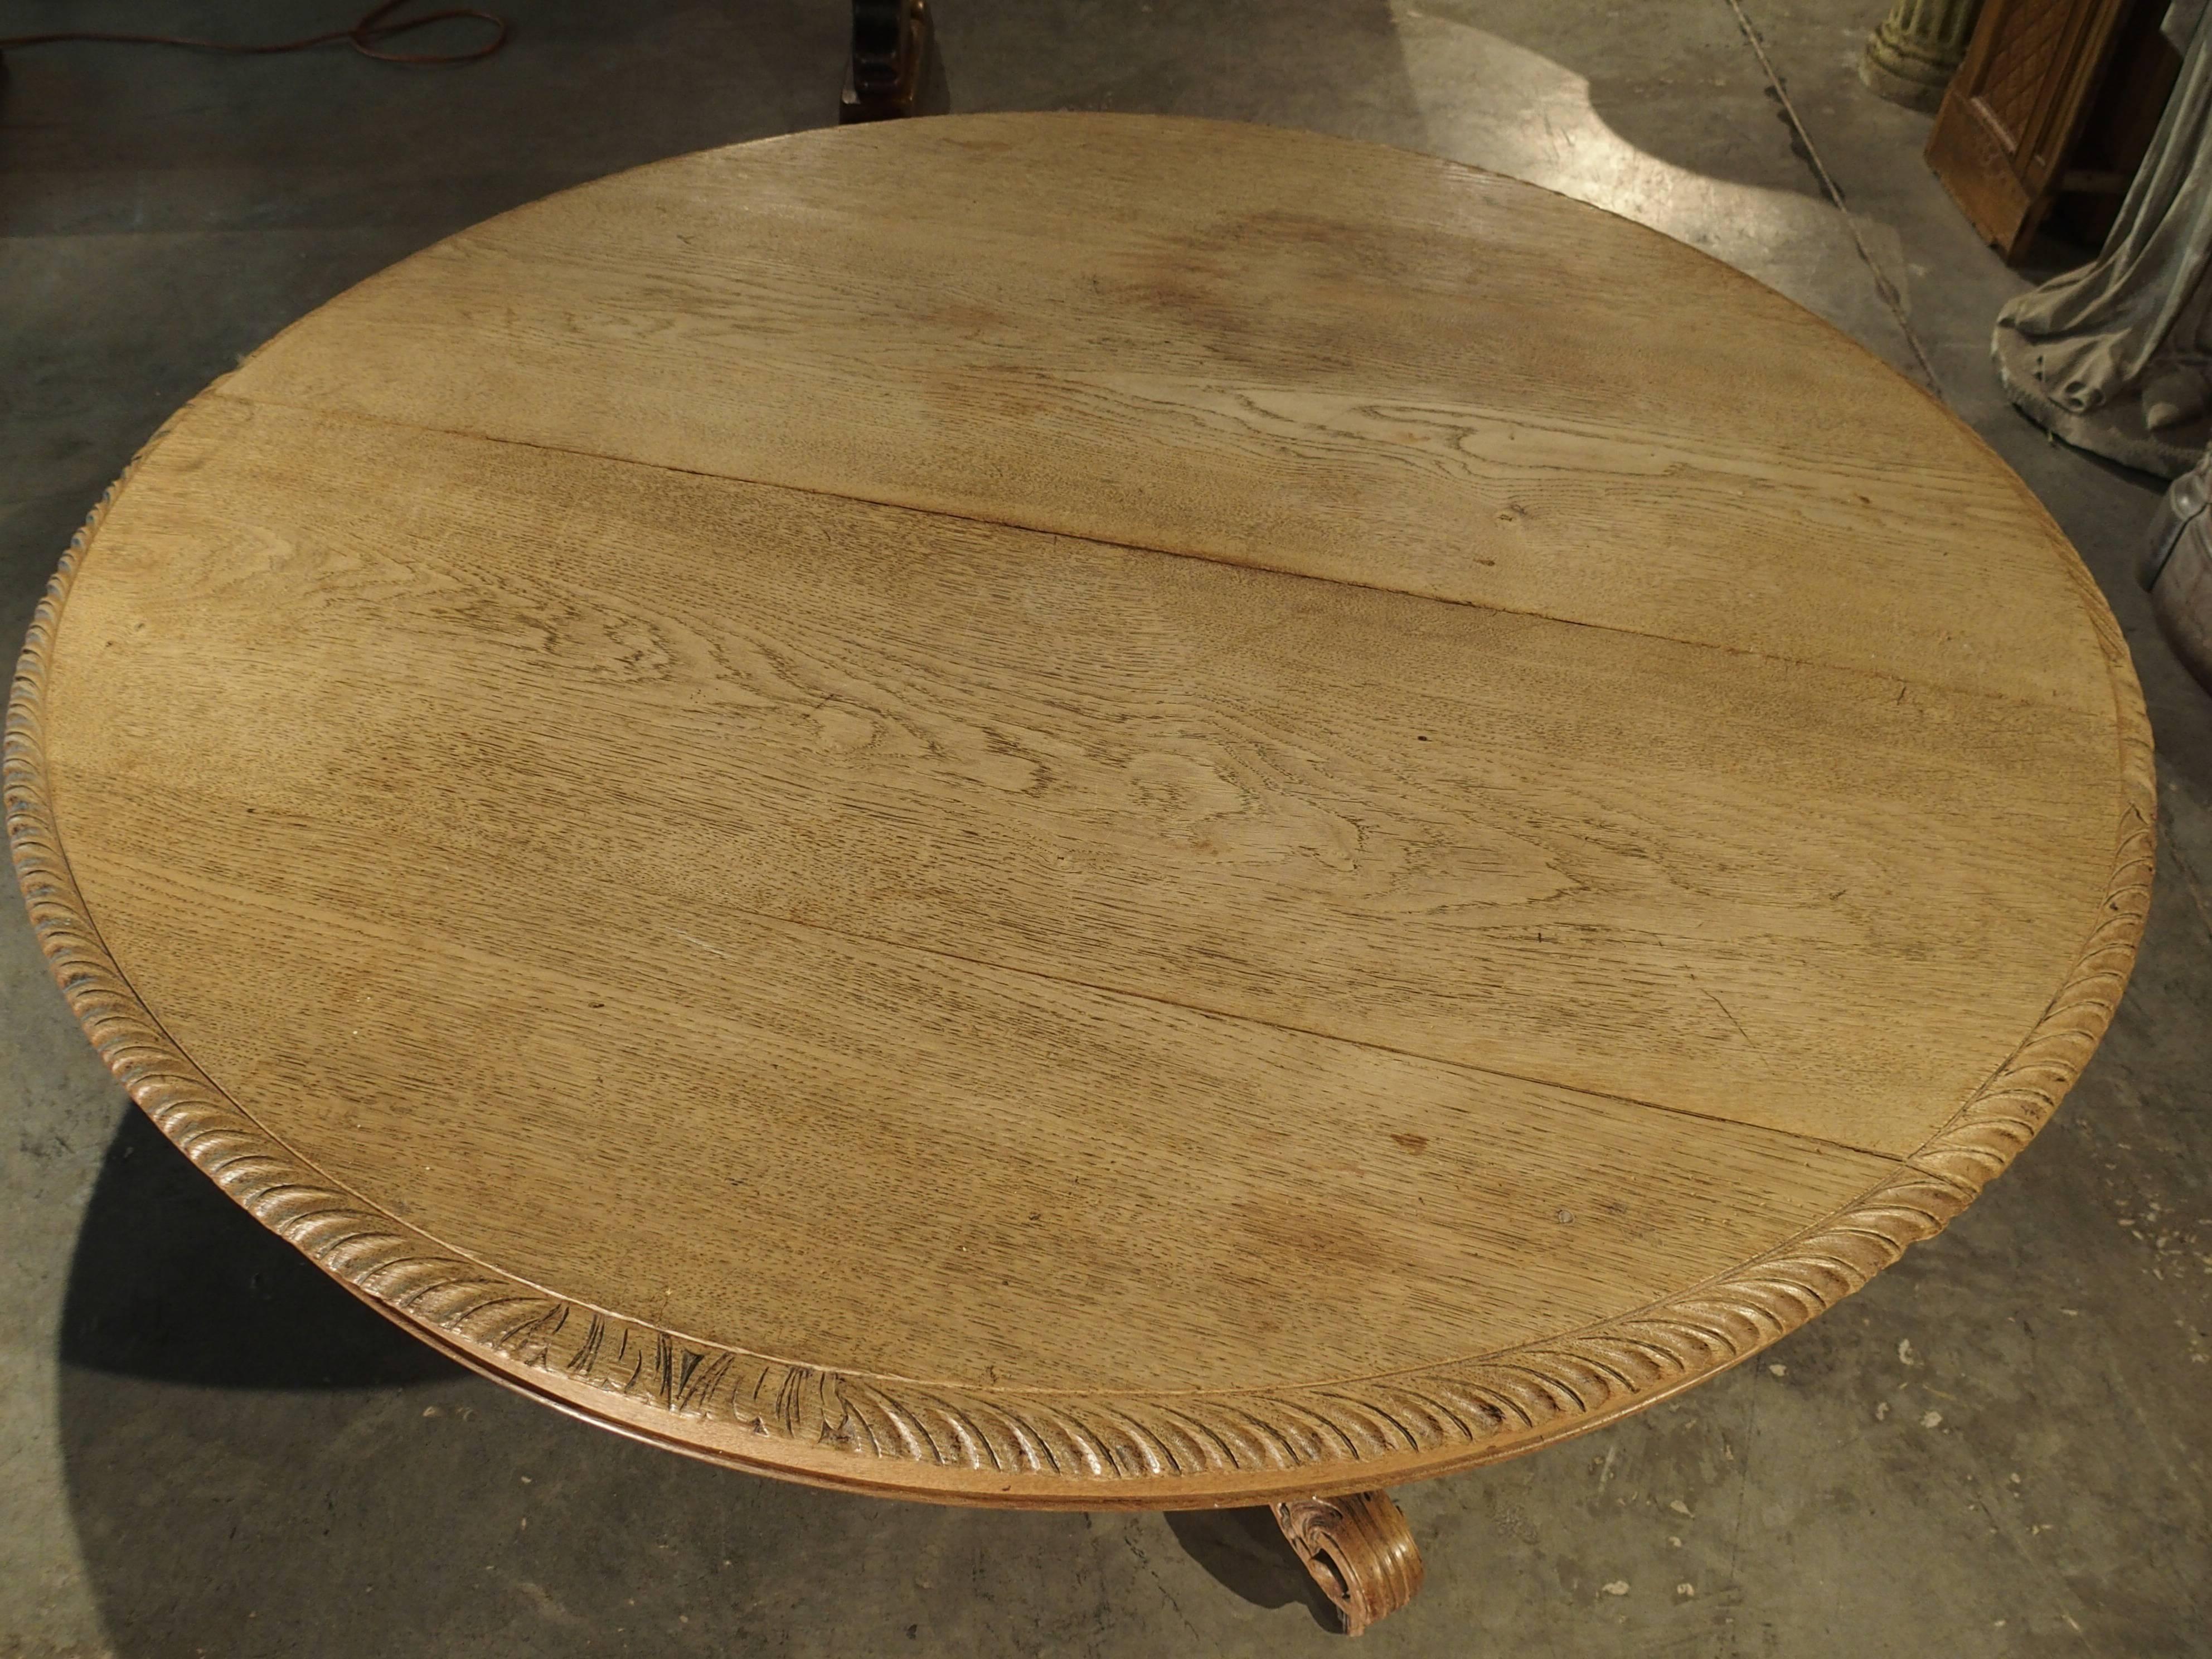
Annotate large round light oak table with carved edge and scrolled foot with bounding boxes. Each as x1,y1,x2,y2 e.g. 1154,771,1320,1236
7,115,2152,1628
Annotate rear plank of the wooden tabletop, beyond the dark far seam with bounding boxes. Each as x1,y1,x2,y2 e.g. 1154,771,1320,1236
232,115,2110,717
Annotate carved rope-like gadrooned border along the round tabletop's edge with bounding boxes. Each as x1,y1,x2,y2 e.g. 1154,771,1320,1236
4,420,2157,1504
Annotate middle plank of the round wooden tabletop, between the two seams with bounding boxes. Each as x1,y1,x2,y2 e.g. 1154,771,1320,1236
57,398,2119,1154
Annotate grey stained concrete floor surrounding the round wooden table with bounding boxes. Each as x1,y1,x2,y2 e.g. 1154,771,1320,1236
0,0,2212,1659
